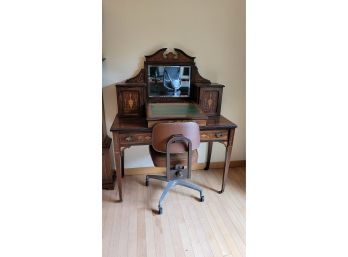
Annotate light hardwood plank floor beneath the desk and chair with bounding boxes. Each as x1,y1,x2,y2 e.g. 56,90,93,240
103,167,245,257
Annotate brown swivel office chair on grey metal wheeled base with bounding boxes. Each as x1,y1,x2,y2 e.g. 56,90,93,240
145,122,204,214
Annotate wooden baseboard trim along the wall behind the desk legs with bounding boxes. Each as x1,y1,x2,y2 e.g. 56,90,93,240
124,160,246,175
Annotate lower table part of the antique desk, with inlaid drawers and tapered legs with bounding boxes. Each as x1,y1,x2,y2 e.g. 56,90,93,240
110,115,237,201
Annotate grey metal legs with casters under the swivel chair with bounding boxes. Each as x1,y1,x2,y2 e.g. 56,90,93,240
145,175,204,214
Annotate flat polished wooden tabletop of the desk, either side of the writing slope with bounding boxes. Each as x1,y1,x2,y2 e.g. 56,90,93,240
110,115,237,132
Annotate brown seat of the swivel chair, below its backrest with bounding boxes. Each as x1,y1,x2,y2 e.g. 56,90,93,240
149,145,198,167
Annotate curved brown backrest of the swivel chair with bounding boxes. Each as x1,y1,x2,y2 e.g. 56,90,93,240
152,122,200,153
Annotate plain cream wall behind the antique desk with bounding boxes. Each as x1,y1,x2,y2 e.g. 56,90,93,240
103,0,246,167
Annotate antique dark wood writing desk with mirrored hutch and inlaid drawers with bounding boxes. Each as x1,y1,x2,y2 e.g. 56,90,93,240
110,48,237,201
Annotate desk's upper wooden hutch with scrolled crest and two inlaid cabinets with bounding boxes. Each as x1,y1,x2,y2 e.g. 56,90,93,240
116,48,224,118
